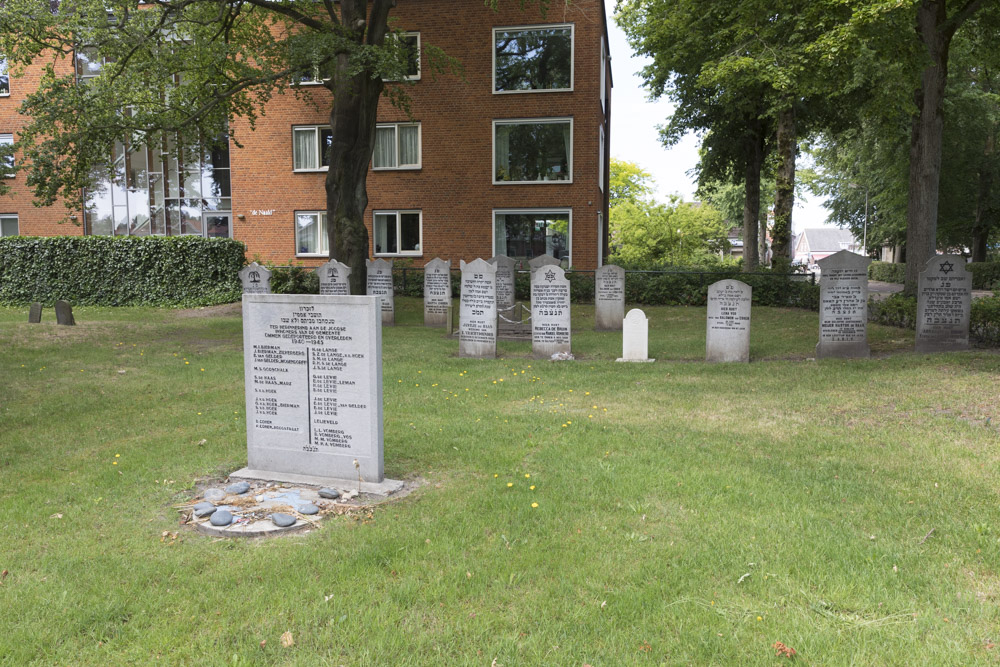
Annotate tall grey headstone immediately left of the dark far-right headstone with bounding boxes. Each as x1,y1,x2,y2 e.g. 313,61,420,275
816,250,871,358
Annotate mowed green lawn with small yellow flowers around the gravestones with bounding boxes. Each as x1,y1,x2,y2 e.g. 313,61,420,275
0,299,1000,666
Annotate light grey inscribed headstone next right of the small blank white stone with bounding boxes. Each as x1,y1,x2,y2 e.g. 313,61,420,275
705,280,752,363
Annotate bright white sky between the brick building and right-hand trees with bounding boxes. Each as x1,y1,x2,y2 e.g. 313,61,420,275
605,0,835,233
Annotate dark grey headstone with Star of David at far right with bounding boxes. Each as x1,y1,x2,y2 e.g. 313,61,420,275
916,255,972,352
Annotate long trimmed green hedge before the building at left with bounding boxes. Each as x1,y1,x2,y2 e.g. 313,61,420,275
0,236,246,306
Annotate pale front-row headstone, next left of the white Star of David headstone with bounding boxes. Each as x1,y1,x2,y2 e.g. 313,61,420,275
458,259,497,359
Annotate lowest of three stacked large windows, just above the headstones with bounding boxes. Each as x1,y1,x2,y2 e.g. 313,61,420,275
493,209,571,265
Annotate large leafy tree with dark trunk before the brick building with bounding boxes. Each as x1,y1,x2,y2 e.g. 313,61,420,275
0,0,549,294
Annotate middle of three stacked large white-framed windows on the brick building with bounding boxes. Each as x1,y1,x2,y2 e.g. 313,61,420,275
493,118,573,183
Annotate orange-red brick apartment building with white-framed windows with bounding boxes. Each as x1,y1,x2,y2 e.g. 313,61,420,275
0,0,611,269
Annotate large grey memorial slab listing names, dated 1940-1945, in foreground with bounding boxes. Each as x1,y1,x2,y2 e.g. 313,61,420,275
243,294,384,483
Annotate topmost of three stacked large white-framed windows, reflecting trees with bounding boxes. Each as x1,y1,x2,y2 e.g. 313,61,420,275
493,25,573,93
